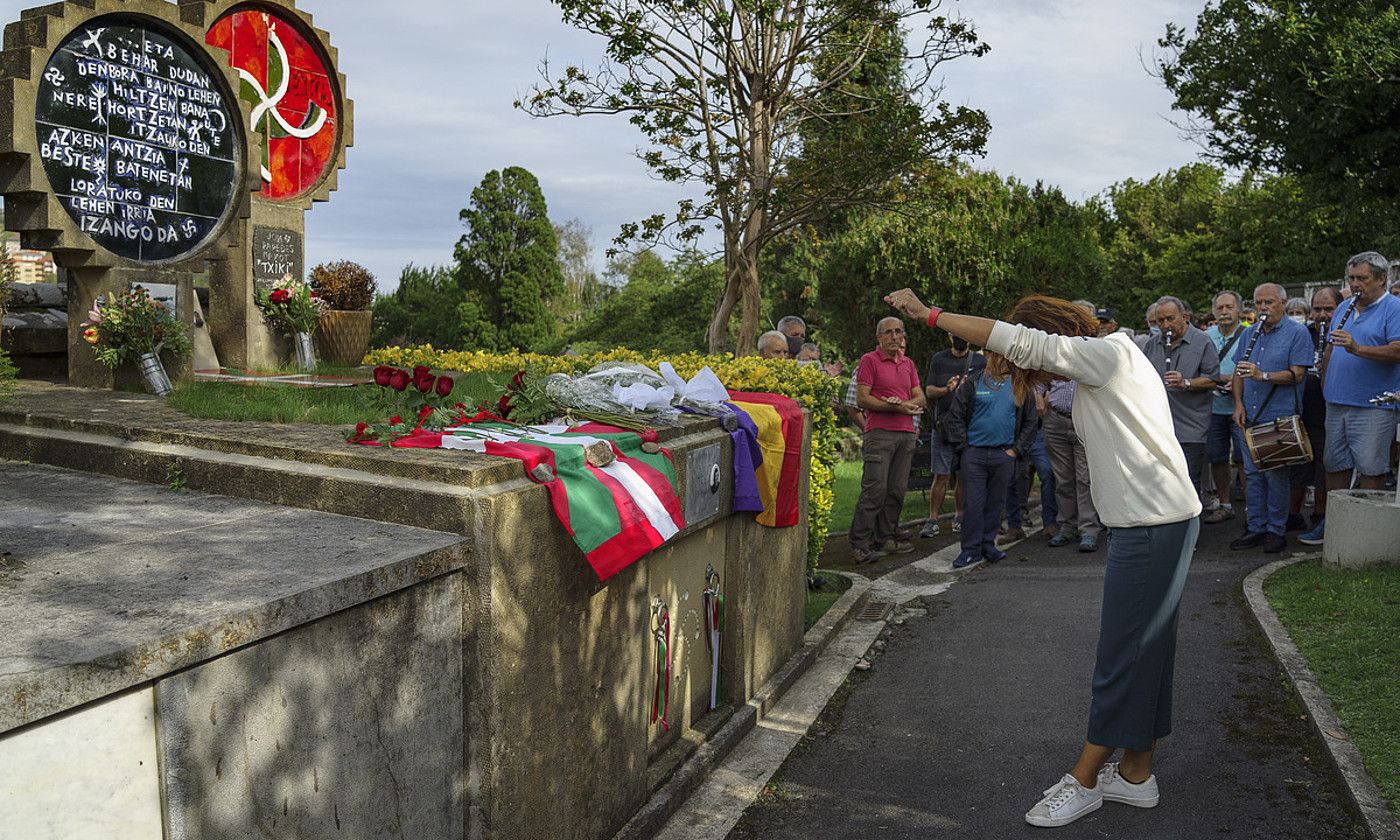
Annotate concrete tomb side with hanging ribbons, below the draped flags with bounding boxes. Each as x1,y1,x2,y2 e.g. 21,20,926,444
470,417,809,840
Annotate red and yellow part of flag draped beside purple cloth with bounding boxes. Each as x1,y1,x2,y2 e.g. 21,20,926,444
729,391,802,528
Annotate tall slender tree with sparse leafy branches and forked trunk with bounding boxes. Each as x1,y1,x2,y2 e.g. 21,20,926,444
517,0,987,353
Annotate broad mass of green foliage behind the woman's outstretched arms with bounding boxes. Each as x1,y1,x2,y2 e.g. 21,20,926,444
812,168,1105,360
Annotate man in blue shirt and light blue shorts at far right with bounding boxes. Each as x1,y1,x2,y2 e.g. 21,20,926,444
1315,251,1400,542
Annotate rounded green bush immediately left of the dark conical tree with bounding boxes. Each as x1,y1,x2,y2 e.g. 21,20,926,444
370,263,465,349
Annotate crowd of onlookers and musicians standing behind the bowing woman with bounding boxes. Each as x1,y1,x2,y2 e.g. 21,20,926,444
817,251,1400,567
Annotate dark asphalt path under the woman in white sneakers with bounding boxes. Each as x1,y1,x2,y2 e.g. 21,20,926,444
729,524,1364,840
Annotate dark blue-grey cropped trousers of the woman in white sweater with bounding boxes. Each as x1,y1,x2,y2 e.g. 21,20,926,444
1086,517,1201,752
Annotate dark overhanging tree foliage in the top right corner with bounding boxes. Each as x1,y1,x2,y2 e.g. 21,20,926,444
1158,0,1400,196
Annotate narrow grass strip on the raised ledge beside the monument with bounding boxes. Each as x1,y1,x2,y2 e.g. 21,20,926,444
165,381,375,426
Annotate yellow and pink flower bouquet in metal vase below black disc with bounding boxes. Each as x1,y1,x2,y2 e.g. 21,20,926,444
81,286,190,396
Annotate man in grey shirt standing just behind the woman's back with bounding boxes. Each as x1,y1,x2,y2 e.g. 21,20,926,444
1142,295,1221,494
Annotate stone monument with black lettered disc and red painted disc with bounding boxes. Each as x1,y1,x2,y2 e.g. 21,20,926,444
0,0,351,388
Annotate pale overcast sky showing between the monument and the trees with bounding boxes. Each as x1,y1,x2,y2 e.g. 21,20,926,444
292,0,1203,288
